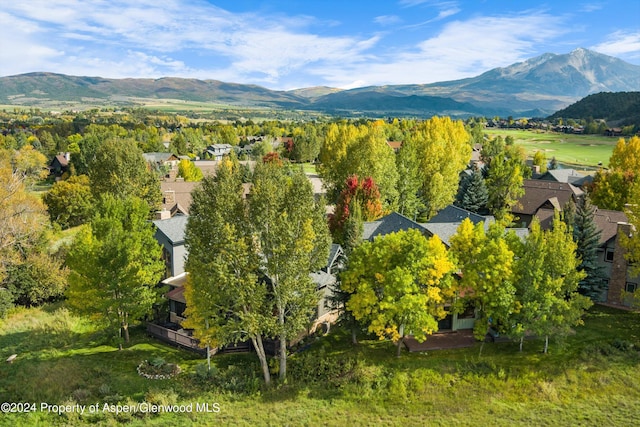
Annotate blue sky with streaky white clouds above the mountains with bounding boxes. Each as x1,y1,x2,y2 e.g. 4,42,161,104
0,0,640,89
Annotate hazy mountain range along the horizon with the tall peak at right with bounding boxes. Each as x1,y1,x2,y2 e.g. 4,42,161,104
0,48,640,117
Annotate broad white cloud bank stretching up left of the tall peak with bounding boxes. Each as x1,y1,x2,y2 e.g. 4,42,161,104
327,13,566,87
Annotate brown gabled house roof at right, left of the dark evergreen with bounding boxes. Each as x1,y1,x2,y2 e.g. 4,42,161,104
512,179,584,215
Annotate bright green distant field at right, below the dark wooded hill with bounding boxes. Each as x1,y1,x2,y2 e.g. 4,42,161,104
486,129,619,169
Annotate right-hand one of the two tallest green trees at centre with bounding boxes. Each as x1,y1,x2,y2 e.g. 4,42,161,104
249,162,331,380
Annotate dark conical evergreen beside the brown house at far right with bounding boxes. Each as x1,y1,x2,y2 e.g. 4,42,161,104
571,196,605,300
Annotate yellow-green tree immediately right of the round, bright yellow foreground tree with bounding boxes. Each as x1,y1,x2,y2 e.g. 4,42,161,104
450,218,518,340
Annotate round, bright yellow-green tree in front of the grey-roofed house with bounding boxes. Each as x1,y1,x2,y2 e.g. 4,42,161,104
341,230,453,356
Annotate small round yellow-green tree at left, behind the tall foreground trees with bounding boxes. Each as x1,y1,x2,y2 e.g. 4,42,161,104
42,175,94,229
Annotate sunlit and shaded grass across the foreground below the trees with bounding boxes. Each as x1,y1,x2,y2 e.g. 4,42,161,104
0,305,640,426
